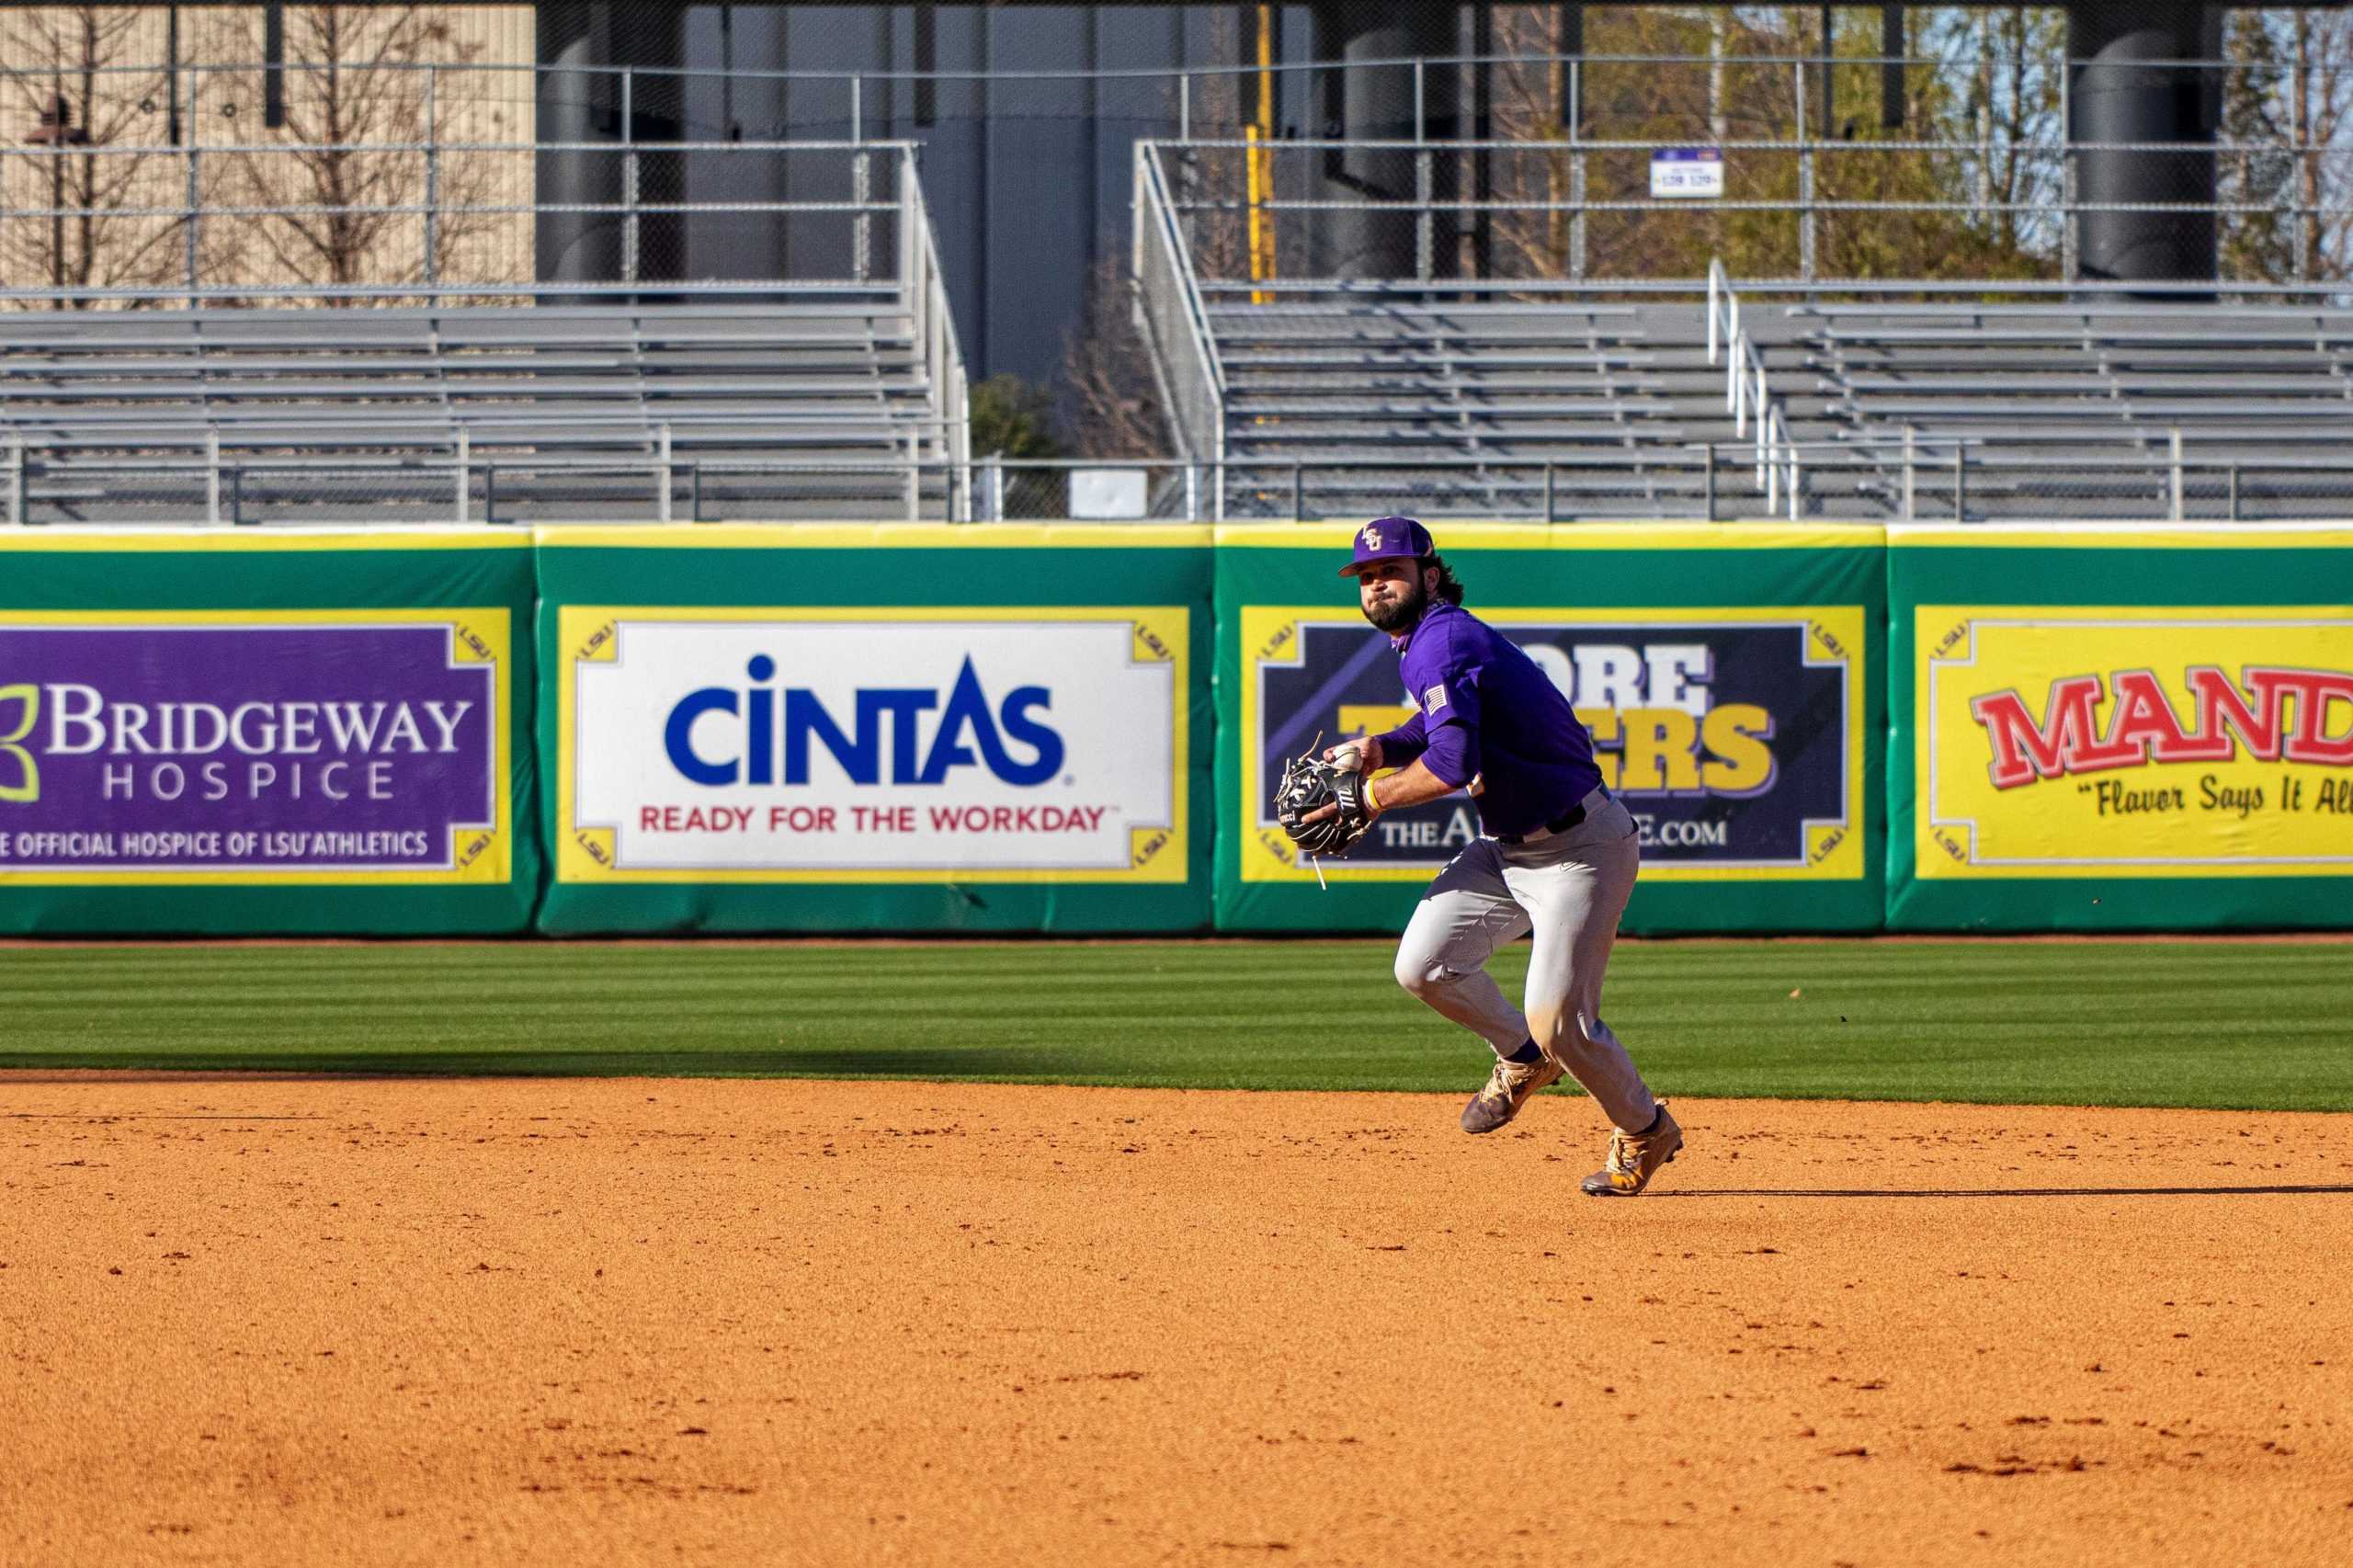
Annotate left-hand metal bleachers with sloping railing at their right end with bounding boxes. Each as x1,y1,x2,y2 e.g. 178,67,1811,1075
0,148,967,523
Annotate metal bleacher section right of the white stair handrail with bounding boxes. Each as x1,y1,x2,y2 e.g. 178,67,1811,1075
1748,301,2353,518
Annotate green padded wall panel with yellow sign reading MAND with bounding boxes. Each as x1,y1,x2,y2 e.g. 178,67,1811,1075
1890,525,2353,930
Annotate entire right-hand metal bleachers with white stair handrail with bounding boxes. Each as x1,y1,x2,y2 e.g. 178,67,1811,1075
1136,143,2353,520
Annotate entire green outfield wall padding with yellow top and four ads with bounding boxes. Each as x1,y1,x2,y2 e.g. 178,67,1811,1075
0,523,2353,935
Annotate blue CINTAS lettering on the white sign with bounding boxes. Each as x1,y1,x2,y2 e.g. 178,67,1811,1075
661,654,1066,787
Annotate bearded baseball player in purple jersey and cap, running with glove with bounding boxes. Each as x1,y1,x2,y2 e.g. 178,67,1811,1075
1303,518,1682,1199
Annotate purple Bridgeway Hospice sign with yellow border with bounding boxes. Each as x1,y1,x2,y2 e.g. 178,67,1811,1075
0,609,508,881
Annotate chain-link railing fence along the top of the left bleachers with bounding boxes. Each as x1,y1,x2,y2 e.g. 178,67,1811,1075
0,131,906,309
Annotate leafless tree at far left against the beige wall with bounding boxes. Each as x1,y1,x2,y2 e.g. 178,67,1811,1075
0,5,186,309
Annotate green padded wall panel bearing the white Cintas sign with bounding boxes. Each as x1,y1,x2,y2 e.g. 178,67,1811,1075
541,525,1211,930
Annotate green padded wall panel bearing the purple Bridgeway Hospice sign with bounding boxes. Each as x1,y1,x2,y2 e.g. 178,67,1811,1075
0,529,539,932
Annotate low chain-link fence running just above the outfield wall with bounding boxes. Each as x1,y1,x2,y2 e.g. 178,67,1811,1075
18,440,2353,528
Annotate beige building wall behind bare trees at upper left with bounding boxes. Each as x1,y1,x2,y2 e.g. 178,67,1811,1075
0,5,534,309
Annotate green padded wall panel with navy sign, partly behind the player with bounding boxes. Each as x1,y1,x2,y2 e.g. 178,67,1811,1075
1217,525,1885,932
